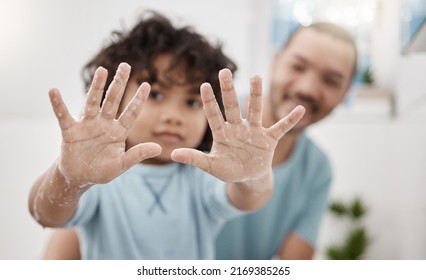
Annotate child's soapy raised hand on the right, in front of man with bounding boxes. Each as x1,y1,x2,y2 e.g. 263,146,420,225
172,69,305,186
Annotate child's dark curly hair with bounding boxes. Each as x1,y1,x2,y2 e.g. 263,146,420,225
82,11,237,151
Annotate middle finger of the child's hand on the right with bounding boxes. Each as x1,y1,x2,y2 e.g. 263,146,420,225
219,69,241,123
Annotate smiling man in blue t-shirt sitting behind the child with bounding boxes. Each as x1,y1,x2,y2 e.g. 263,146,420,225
216,23,357,259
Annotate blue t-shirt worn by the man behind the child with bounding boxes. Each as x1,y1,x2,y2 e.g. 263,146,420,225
216,134,332,259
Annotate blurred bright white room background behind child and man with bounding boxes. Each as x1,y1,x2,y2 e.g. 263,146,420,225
0,0,426,259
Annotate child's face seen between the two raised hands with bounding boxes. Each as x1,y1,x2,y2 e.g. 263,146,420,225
119,55,207,164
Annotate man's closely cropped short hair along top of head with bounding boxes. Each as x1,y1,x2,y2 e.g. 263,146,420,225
283,22,358,77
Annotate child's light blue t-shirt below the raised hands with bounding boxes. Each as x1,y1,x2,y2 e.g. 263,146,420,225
66,163,242,259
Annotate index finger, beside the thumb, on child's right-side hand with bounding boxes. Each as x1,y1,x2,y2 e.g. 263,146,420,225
200,83,225,135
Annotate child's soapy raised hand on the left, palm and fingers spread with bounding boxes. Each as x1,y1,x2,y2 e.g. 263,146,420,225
49,63,161,186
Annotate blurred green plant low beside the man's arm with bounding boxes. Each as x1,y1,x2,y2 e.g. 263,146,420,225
326,197,370,260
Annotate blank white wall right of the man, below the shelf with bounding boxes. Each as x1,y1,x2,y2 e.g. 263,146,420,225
309,104,426,259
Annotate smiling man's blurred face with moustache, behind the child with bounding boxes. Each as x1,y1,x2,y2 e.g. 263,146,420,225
269,29,356,131
